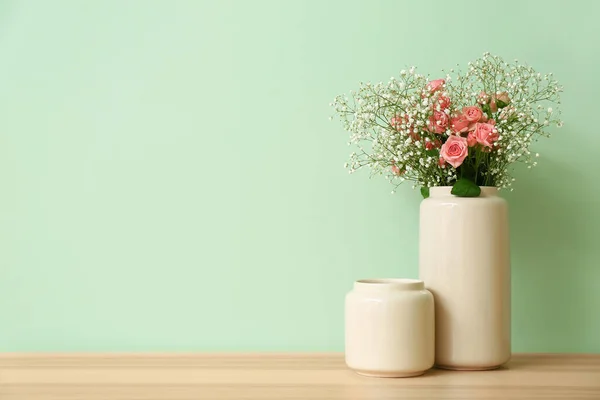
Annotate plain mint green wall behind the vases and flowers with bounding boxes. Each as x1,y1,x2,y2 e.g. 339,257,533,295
0,0,600,352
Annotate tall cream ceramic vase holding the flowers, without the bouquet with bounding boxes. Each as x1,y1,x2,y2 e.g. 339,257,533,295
419,187,511,370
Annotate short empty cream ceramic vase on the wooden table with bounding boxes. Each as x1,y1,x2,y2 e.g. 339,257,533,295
346,279,435,378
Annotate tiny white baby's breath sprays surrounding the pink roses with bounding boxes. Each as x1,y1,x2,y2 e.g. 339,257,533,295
332,53,563,195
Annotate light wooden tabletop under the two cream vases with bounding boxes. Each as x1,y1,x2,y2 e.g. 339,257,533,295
0,354,600,400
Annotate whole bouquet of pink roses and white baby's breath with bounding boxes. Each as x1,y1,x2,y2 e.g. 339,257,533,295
331,53,562,197
